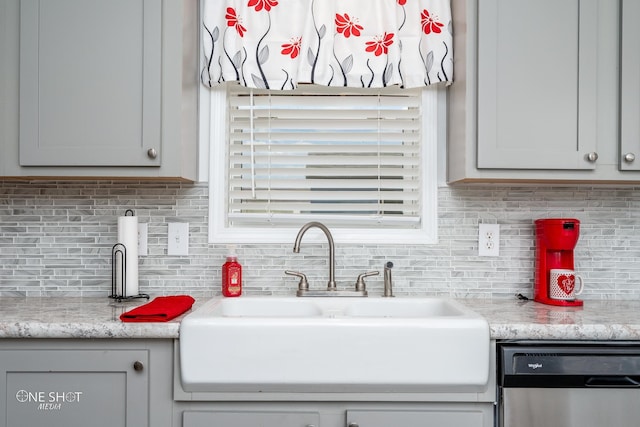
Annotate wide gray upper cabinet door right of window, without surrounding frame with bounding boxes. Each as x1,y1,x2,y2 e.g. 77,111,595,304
477,0,598,169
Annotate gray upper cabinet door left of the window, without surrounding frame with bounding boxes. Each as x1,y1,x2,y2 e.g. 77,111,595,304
20,0,162,166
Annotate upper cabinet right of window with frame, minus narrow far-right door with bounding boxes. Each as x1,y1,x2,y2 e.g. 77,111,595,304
448,0,624,182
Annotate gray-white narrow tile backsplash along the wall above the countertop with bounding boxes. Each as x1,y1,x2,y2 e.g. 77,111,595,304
0,181,640,300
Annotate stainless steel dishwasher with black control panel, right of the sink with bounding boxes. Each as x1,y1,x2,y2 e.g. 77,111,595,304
496,341,640,427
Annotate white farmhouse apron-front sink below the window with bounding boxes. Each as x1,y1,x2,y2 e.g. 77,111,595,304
180,297,489,392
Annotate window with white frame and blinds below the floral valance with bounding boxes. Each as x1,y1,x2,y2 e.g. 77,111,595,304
207,86,442,244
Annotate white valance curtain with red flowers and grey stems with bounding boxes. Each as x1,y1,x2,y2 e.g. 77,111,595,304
201,0,453,90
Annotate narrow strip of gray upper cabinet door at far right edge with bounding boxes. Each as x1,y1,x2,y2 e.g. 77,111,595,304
620,0,640,170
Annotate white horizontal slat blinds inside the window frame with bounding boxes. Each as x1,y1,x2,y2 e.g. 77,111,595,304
226,87,423,229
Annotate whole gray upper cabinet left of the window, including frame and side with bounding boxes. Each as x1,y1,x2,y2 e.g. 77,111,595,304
0,0,198,180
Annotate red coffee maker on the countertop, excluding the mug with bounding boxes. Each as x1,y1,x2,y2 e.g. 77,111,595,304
533,218,583,306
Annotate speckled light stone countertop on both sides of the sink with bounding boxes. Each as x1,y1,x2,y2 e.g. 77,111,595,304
0,297,640,340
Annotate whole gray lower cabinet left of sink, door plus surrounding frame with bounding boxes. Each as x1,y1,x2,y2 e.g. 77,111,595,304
0,340,172,427
